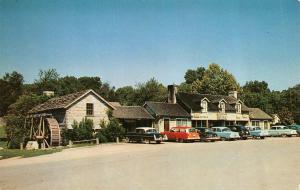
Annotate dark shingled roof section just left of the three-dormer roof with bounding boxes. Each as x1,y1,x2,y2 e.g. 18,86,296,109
144,102,191,118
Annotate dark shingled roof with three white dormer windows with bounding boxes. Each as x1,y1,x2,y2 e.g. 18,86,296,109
176,92,249,112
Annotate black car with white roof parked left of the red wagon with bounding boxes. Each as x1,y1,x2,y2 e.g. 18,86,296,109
125,127,167,144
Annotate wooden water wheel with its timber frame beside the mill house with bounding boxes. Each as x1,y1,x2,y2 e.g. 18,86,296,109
25,114,61,147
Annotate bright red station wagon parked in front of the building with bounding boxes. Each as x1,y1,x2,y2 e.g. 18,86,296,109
161,127,200,142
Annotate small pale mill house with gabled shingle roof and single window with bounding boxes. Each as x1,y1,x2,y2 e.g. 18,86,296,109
30,89,116,129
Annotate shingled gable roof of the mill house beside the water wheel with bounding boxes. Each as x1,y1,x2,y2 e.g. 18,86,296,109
29,89,115,113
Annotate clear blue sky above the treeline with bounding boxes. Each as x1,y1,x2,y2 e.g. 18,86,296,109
0,0,300,90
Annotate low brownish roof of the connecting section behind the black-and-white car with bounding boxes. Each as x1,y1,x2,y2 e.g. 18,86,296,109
113,106,154,119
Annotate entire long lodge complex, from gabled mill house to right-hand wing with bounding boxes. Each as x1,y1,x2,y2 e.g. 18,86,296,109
30,85,272,132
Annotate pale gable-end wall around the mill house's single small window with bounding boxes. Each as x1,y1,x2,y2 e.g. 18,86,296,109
65,94,110,129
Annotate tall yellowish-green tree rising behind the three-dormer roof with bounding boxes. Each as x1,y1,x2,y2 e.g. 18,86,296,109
192,63,240,95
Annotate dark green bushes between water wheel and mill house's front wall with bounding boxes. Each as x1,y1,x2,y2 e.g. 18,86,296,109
62,118,94,142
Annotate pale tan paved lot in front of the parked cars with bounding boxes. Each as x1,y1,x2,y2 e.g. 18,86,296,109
0,137,300,190
